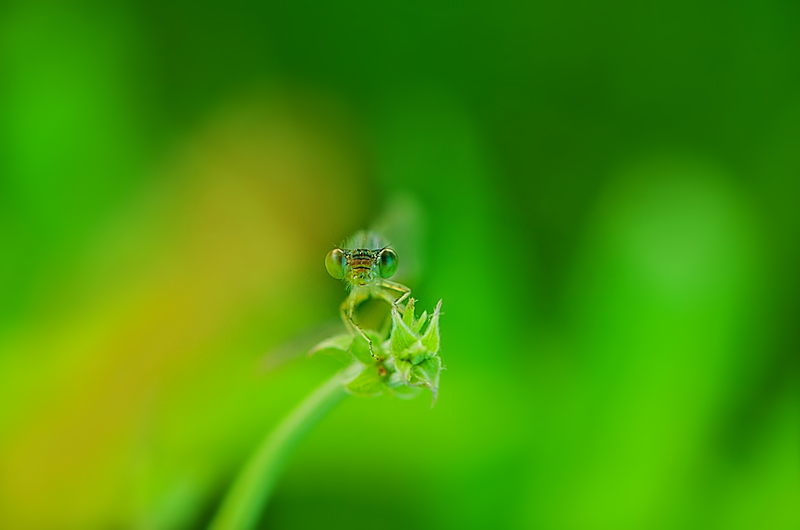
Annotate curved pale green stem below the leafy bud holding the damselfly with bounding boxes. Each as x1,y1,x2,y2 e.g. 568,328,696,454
210,373,346,530
